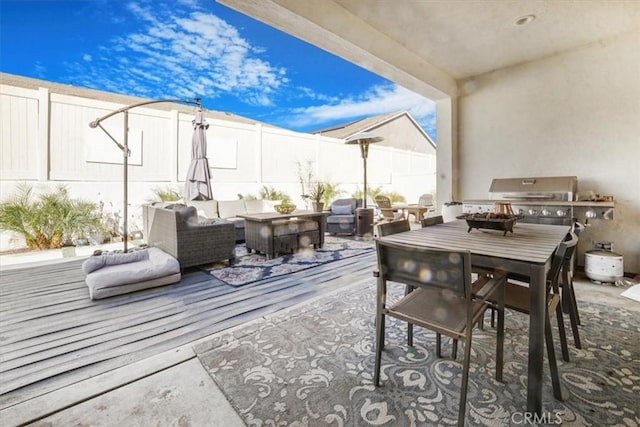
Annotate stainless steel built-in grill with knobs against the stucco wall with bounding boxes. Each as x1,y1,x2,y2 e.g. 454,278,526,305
462,176,614,225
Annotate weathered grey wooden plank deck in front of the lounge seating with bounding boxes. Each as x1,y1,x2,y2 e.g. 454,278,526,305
0,252,376,410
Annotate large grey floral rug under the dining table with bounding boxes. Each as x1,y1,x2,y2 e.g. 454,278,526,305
196,285,640,426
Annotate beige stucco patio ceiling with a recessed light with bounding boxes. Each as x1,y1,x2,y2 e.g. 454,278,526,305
218,0,640,99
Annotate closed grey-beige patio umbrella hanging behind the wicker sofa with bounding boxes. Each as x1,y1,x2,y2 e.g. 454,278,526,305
184,111,213,200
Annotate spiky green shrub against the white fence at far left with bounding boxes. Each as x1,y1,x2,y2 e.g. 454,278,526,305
0,183,102,249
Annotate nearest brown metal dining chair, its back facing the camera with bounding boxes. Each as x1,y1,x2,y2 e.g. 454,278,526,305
374,240,505,426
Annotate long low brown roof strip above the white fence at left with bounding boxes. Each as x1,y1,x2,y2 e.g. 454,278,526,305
0,73,280,129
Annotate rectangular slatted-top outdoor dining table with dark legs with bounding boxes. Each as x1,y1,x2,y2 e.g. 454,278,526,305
380,220,569,415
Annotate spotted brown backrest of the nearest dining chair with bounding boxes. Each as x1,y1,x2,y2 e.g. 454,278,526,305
376,239,471,299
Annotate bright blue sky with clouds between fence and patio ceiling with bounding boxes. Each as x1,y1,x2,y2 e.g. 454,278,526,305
0,0,435,140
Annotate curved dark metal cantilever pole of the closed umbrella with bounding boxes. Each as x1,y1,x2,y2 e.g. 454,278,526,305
89,98,202,252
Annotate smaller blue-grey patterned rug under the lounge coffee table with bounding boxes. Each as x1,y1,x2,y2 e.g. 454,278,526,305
208,236,374,286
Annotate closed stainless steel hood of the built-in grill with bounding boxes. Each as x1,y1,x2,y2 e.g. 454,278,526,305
489,176,578,201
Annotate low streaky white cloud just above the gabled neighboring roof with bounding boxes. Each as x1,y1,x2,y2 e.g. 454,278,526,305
287,84,435,135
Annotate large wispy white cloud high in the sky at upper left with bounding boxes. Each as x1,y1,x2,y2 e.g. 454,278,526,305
69,0,289,106
